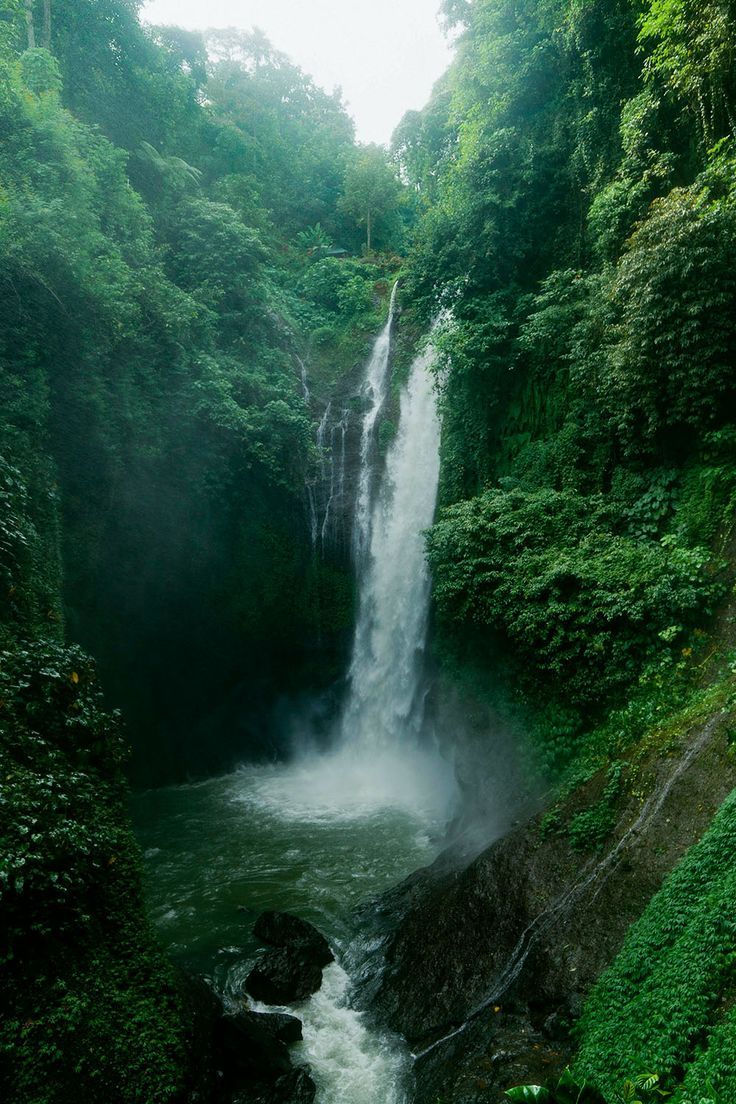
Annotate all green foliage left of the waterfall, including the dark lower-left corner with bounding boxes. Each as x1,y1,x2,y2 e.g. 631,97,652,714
0,0,408,1104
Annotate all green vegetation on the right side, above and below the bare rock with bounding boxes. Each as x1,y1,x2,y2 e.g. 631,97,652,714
395,0,736,1104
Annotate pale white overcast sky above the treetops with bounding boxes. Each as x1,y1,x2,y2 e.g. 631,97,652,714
142,0,450,142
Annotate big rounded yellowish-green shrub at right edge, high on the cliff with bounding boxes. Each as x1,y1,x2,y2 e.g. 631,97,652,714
591,162,736,454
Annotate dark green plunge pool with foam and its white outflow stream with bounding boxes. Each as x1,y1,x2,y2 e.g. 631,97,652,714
132,760,452,1104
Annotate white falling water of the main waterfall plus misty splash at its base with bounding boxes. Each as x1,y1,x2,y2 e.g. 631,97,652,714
268,330,456,825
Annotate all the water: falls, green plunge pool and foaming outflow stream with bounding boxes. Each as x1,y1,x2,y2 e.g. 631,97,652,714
135,304,455,1104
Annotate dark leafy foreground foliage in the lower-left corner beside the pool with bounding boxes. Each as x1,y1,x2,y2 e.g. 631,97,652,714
0,643,191,1104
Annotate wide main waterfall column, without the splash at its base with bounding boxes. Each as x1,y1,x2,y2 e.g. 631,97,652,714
342,335,440,750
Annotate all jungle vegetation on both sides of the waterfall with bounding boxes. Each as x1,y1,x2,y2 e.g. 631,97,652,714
0,0,736,1104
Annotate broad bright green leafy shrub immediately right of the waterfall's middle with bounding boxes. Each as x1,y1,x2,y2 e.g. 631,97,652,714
428,489,723,702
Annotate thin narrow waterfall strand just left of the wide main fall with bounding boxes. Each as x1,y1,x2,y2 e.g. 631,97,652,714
353,280,398,566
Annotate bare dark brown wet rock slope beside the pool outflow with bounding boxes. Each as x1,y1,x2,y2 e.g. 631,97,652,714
366,708,735,1104
